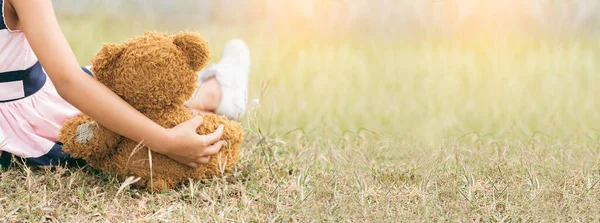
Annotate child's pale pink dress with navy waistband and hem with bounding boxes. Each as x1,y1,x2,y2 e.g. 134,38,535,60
0,0,84,165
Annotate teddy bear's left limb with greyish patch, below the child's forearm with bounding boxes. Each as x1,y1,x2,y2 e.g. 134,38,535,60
58,114,124,159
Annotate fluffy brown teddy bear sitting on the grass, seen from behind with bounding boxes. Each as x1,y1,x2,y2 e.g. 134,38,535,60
59,32,243,191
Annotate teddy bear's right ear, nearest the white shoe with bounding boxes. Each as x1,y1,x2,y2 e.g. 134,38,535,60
172,32,210,71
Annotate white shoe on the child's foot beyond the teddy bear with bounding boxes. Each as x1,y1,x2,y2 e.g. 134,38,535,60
198,39,250,120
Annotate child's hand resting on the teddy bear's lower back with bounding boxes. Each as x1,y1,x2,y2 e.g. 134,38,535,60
151,116,225,168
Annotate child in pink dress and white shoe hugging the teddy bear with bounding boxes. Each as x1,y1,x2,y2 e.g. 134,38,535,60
0,0,250,167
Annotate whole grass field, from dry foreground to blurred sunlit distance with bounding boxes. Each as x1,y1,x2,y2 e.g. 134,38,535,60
0,13,600,222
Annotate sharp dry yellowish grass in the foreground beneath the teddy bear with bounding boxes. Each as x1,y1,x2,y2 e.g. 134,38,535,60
0,136,600,222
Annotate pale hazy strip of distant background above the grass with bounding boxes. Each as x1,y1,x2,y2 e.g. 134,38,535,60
55,0,600,36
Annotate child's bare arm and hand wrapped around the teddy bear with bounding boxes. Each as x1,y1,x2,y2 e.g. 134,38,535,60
11,0,223,167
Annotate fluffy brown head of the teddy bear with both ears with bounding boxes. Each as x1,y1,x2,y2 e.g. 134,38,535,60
92,32,210,110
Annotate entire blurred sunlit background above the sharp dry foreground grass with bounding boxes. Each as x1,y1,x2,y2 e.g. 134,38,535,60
53,0,600,142
